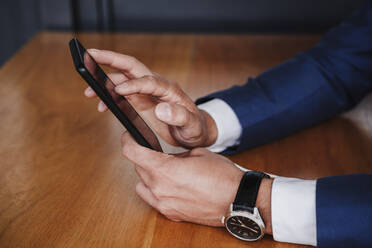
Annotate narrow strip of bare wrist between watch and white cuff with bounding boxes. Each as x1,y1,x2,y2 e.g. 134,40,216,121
256,178,274,234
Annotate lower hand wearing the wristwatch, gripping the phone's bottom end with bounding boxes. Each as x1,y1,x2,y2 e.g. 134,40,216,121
122,132,272,233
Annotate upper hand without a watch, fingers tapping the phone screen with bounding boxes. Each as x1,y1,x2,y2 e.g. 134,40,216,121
85,49,217,148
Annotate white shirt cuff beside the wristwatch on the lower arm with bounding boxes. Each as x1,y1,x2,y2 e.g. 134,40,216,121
271,177,317,246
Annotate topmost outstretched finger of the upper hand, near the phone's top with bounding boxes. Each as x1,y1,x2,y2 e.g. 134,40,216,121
88,49,152,78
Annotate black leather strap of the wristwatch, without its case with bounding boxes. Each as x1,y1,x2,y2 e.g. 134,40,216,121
233,171,270,213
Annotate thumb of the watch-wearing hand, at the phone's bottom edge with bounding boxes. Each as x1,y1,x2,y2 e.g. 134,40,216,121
121,132,174,171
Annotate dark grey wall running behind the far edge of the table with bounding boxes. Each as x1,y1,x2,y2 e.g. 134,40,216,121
0,0,364,65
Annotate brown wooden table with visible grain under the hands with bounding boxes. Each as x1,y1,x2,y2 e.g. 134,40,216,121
0,33,372,248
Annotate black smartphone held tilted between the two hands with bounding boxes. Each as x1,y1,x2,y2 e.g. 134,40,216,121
69,38,162,152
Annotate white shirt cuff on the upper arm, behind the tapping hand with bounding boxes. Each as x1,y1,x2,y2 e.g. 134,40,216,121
198,98,242,152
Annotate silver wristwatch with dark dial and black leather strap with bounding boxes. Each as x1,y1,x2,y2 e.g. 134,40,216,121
222,171,270,241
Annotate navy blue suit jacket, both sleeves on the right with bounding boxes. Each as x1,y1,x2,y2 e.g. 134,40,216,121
197,1,372,247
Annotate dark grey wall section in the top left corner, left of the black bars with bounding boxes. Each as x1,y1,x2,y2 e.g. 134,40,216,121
0,0,72,65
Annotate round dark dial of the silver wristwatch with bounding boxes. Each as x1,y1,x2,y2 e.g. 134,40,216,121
226,216,261,240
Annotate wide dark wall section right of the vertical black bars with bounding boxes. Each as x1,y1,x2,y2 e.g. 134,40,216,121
109,0,364,32
